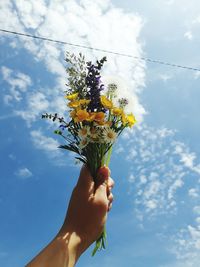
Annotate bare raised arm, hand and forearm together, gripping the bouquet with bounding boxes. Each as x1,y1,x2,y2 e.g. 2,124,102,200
26,166,114,267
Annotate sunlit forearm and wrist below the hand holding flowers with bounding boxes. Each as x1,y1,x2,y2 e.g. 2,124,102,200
26,232,80,267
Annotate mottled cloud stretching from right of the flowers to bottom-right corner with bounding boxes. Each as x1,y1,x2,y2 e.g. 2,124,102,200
119,124,200,267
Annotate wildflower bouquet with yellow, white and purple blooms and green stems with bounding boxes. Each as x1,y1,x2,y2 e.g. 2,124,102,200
42,53,136,255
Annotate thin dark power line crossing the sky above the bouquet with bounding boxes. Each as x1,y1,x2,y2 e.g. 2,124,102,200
0,29,200,72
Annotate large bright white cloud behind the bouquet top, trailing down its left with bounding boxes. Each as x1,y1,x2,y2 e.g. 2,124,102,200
0,0,145,164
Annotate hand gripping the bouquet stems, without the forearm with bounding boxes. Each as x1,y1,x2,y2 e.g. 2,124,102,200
59,166,114,257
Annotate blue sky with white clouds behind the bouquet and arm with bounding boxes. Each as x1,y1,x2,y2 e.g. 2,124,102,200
0,0,200,267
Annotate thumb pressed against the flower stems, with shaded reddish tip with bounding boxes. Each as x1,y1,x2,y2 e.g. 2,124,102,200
95,166,110,199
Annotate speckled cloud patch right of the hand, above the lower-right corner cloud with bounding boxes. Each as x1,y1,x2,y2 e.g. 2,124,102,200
119,124,199,219
